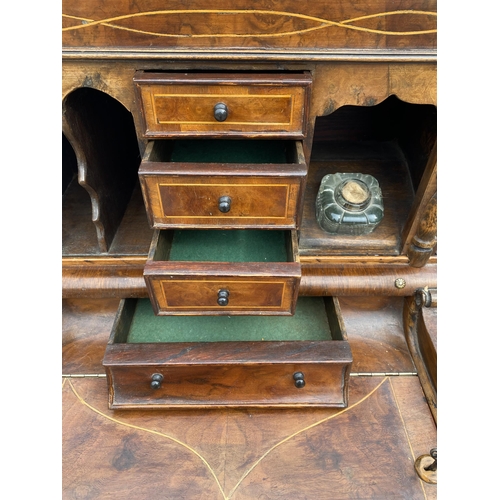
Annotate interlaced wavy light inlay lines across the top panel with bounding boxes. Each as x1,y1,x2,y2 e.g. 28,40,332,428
62,9,437,38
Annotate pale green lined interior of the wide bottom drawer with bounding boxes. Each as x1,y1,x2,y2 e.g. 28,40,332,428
127,297,332,343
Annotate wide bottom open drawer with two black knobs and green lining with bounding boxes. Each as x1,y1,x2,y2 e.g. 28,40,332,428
103,297,352,409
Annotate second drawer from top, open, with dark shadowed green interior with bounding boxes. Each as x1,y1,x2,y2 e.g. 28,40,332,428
139,139,307,229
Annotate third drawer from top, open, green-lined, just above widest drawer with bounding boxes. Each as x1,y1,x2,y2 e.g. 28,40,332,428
144,229,301,316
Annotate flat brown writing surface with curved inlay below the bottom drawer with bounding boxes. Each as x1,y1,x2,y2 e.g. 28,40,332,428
62,376,437,500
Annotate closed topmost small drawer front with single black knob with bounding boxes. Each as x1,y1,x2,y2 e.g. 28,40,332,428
134,72,311,138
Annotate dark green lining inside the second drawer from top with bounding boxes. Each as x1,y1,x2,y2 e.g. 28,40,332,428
171,139,287,163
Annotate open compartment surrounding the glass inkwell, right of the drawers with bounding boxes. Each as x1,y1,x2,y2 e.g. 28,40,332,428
300,96,437,262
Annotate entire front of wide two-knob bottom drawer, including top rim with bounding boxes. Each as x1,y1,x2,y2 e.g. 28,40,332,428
103,334,352,408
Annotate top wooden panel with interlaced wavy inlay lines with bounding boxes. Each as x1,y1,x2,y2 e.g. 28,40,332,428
62,0,437,52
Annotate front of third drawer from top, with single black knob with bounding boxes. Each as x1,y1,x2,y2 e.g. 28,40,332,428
144,262,300,316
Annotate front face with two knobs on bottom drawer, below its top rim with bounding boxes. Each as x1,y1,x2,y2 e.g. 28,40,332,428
108,362,347,409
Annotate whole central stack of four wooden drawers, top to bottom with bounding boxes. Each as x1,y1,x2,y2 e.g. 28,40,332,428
104,72,352,408
